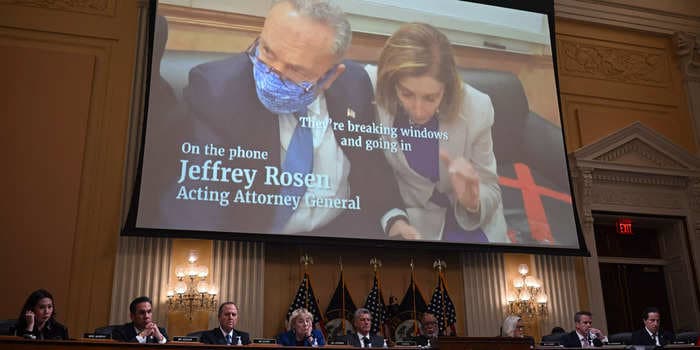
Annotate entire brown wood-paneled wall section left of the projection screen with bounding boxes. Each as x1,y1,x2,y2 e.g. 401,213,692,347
0,0,138,334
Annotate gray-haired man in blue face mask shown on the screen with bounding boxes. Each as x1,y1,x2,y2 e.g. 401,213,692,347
175,0,420,239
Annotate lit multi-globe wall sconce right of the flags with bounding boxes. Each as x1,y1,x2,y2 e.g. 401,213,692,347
506,264,547,318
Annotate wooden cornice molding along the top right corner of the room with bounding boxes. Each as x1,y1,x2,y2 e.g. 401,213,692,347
554,0,700,35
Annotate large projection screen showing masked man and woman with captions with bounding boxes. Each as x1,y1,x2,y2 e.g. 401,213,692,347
122,0,587,254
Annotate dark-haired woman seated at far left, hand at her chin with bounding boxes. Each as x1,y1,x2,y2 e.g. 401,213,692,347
15,289,68,340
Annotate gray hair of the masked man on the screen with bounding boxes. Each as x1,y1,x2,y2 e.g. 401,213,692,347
273,0,352,58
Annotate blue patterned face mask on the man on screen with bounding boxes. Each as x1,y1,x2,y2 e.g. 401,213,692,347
248,47,336,114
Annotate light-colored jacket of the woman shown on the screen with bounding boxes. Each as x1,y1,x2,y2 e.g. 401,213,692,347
365,65,509,243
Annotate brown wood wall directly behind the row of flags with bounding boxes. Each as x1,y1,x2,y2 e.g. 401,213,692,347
264,243,466,336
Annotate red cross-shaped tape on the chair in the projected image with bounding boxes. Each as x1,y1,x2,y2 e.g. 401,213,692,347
498,163,571,242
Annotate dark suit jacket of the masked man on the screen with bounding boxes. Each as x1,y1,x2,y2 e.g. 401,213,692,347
153,53,403,239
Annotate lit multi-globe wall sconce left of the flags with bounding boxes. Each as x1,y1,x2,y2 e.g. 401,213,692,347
167,253,217,321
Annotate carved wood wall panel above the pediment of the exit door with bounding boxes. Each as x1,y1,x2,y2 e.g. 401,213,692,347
556,18,696,153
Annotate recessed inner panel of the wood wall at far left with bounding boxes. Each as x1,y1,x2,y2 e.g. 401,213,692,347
0,41,95,326
